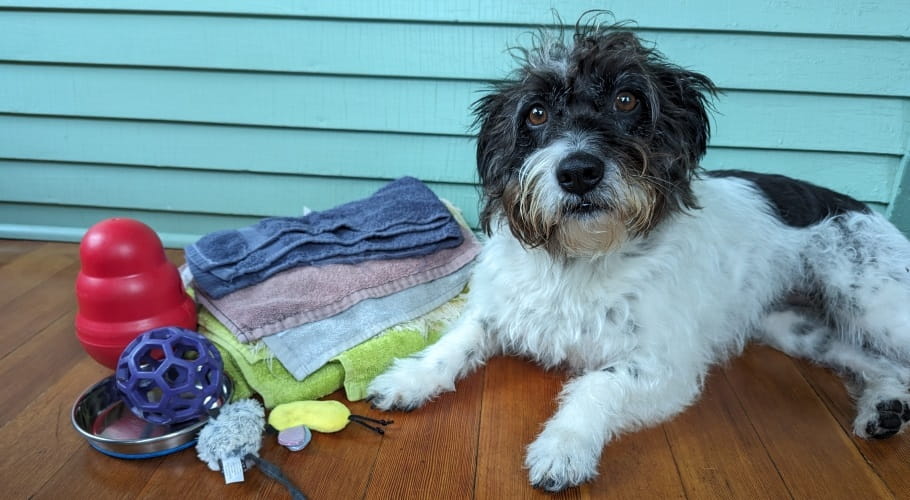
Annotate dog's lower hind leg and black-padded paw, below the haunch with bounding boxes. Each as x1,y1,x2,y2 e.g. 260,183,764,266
760,308,910,439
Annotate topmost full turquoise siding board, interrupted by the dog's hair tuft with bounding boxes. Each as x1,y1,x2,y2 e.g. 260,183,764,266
0,11,910,96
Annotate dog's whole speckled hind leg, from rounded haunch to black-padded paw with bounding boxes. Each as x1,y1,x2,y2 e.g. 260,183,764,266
764,213,910,438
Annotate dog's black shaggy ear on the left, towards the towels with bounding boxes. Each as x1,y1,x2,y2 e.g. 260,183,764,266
474,87,518,234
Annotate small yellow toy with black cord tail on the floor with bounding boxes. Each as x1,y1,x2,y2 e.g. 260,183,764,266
269,400,395,434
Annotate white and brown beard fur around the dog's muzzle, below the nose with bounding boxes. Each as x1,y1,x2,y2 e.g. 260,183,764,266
501,148,658,257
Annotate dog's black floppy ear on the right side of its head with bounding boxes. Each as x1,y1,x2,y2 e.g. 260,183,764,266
652,60,717,163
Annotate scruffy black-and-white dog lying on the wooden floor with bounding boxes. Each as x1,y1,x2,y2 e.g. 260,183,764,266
369,22,910,491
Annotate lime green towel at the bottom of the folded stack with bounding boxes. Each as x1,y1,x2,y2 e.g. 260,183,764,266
199,290,467,408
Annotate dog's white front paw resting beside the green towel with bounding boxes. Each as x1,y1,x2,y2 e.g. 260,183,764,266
367,358,455,411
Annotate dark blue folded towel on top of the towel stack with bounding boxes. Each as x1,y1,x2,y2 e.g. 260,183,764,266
186,177,463,298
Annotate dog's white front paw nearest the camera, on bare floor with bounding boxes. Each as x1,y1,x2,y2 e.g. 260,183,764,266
525,427,601,492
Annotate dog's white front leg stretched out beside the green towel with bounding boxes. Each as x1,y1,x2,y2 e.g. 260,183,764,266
367,312,490,411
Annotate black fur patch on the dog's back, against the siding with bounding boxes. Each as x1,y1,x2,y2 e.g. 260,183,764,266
707,170,870,227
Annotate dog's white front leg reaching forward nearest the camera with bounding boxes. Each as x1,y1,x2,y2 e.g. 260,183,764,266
525,362,706,491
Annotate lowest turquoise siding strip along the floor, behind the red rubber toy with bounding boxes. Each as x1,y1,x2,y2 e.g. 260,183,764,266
0,202,258,248
